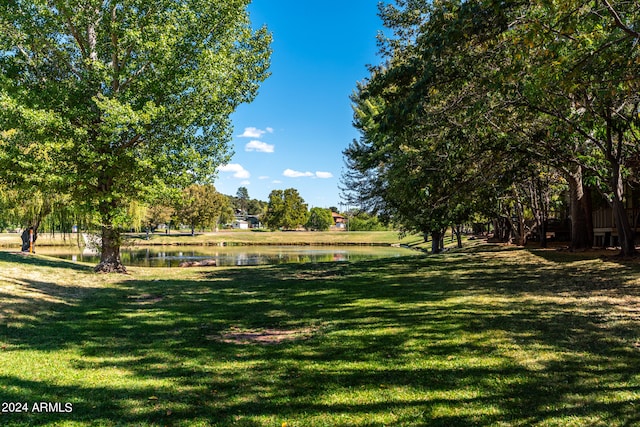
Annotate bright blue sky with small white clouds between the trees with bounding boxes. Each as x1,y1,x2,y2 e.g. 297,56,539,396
215,0,382,211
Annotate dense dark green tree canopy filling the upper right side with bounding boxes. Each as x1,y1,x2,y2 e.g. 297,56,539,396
344,0,640,255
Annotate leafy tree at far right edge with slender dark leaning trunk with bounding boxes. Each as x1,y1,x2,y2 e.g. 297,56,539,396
509,0,640,255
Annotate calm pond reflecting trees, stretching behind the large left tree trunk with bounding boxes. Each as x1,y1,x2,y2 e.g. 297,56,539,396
38,246,416,267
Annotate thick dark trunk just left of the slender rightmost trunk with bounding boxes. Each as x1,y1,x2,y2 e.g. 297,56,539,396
565,166,593,250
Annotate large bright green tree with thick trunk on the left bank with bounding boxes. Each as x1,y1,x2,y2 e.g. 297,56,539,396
0,0,270,272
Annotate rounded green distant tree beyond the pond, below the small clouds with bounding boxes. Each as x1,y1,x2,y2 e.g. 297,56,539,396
264,188,307,230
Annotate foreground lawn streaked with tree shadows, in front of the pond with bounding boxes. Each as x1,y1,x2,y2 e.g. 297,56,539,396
0,246,640,427
